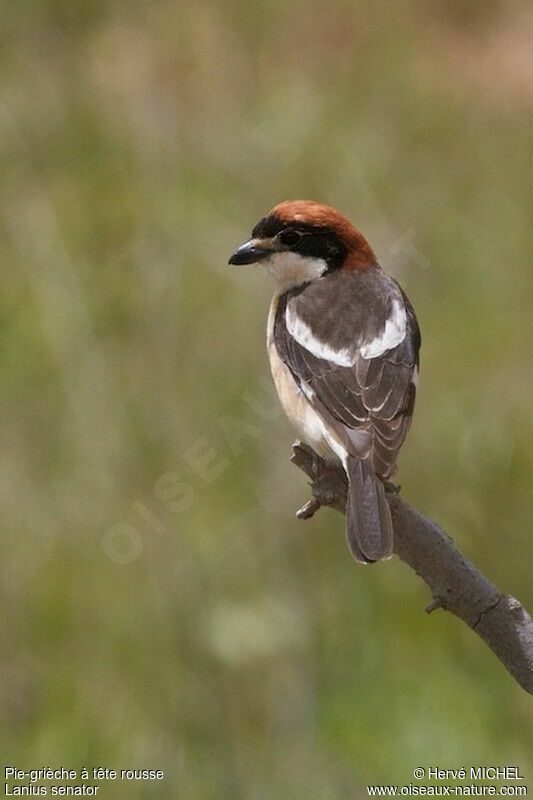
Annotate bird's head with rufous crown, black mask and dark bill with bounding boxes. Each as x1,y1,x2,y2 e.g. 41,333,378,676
229,200,377,293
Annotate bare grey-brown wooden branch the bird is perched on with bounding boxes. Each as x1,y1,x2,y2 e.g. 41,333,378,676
291,442,533,694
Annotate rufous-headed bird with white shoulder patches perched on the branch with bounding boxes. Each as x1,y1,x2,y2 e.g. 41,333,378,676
229,200,421,564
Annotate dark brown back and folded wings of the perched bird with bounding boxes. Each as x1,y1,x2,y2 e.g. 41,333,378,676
274,271,420,478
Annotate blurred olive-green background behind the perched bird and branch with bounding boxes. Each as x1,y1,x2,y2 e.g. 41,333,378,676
0,0,533,800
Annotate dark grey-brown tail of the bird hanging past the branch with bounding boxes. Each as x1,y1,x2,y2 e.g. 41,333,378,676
346,456,393,564
